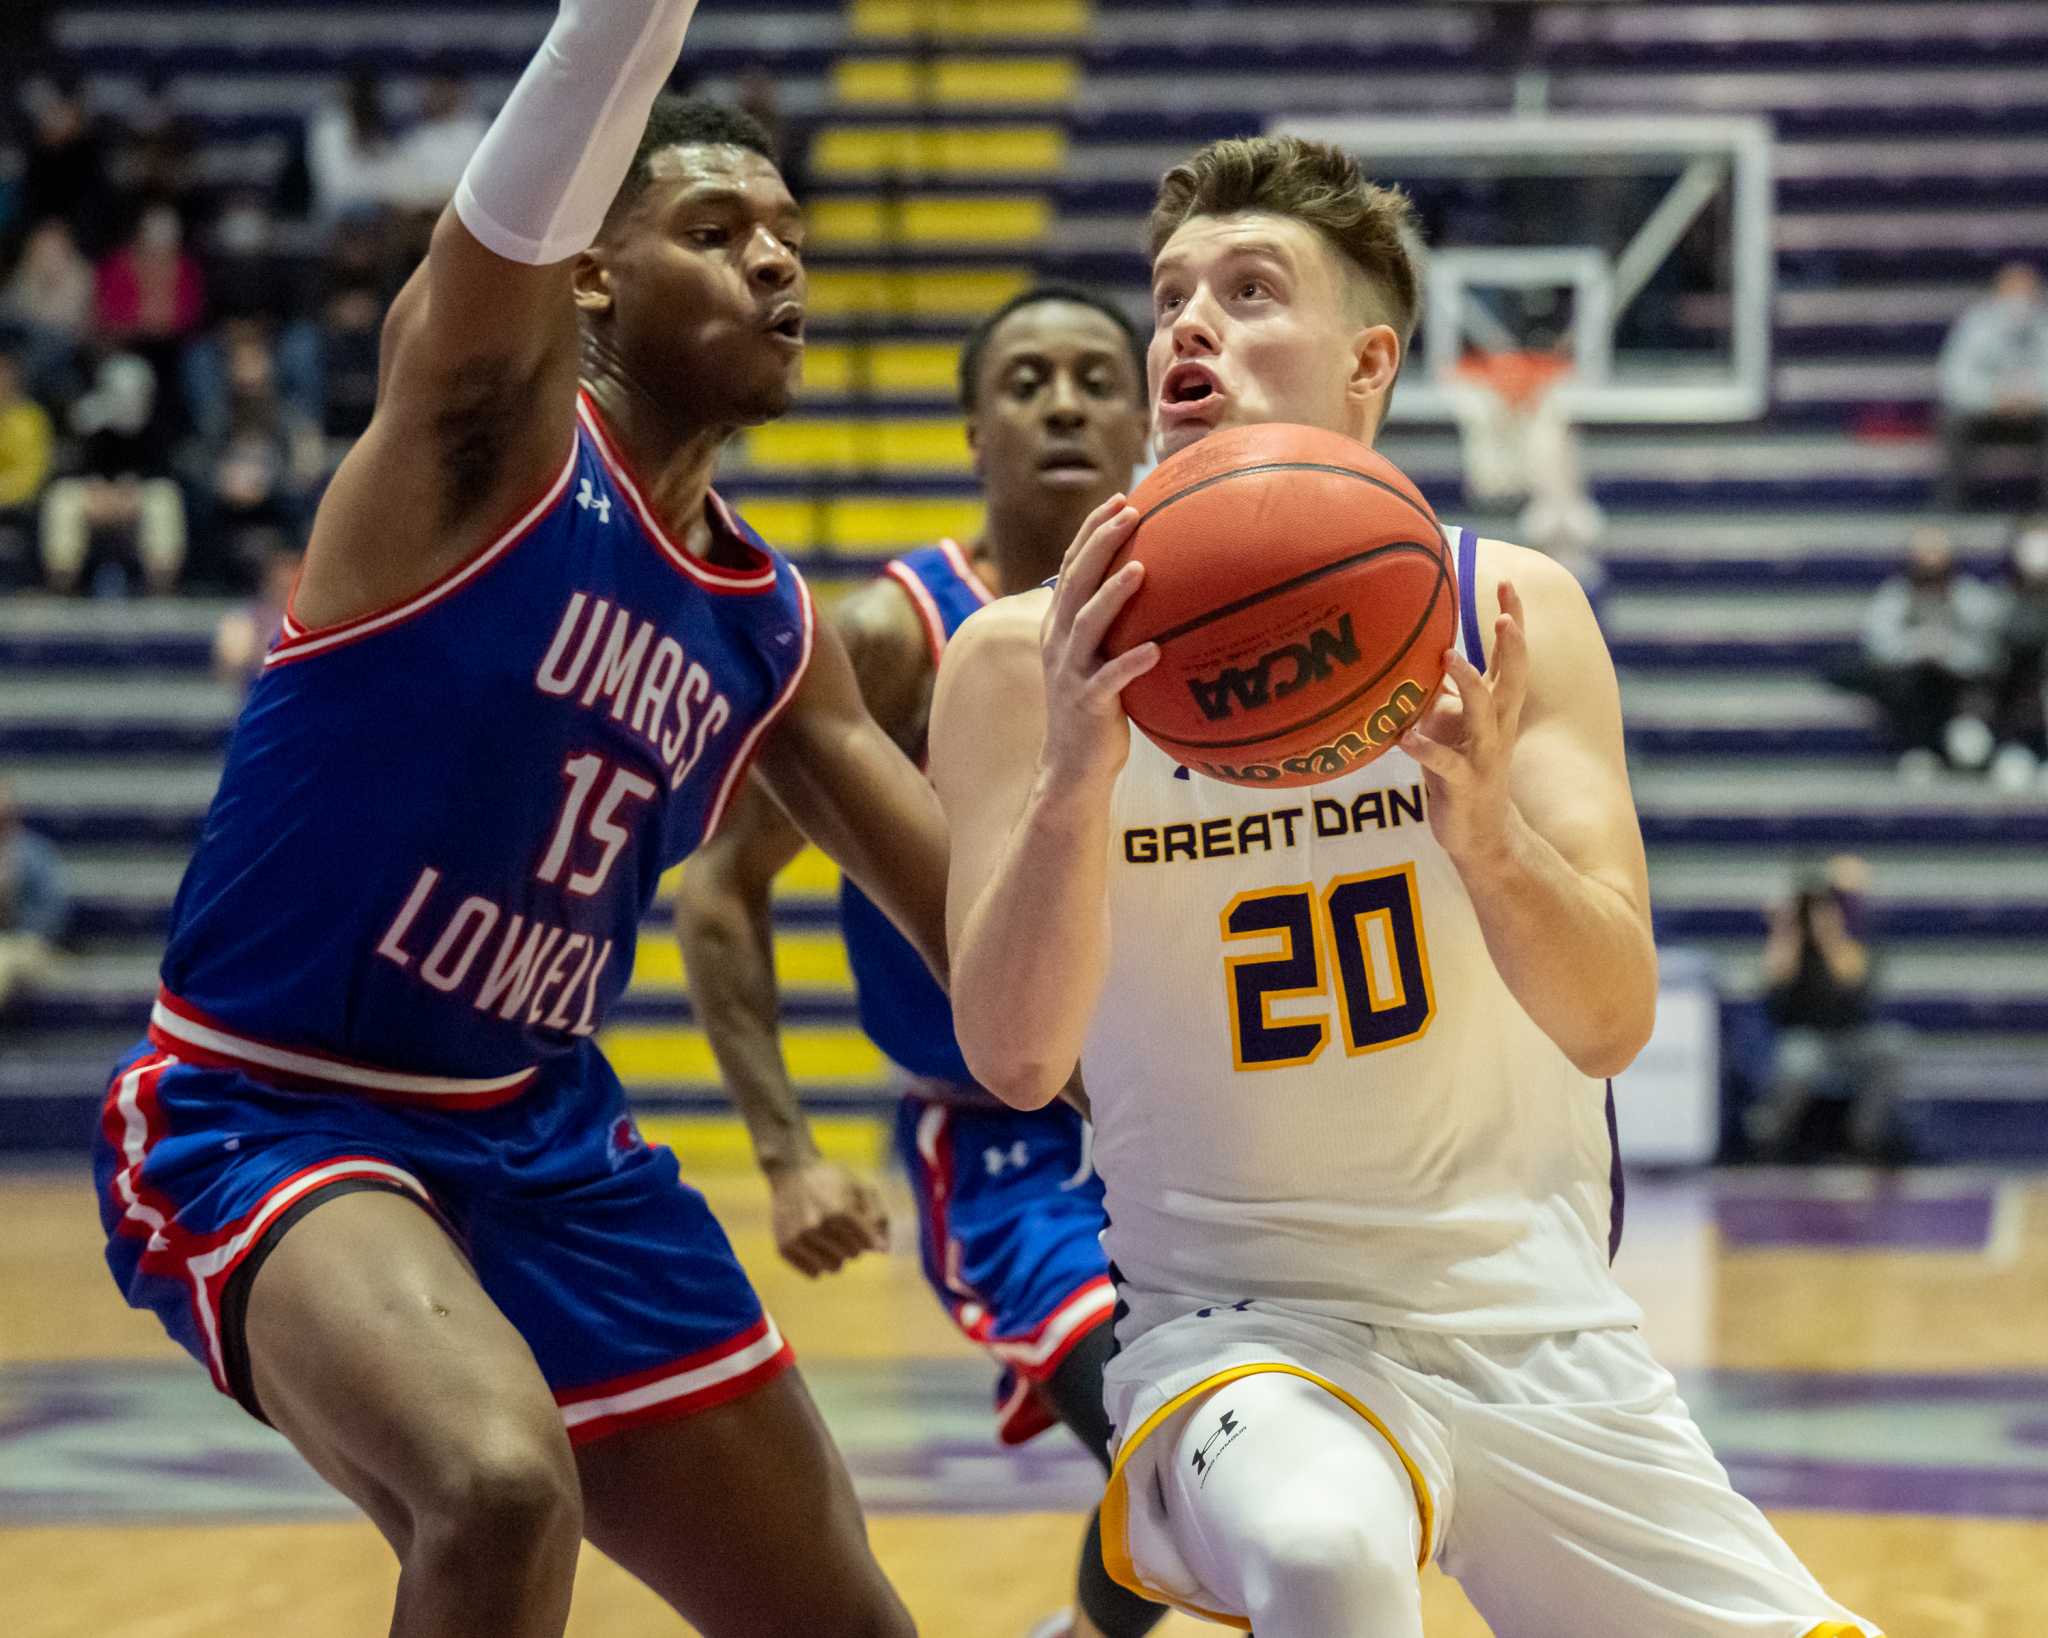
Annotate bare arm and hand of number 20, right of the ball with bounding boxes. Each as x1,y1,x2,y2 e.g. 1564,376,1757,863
1401,541,1657,1075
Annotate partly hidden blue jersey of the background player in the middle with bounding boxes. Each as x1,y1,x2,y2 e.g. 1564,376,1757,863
840,541,989,1087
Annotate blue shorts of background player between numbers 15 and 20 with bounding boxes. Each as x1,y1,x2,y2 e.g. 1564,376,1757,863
897,1095,1116,1446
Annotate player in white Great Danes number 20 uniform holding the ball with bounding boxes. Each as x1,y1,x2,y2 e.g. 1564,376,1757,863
932,137,1876,1638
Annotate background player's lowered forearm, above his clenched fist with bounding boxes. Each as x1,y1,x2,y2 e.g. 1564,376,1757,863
676,872,817,1171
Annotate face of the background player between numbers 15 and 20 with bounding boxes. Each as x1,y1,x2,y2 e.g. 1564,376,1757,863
967,301,1145,520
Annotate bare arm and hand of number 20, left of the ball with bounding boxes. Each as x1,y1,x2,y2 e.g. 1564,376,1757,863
932,495,1159,1110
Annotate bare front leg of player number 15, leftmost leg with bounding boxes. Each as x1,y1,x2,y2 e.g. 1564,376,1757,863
242,1192,582,1638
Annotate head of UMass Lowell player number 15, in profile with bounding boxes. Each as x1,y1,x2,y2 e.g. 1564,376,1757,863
604,145,805,426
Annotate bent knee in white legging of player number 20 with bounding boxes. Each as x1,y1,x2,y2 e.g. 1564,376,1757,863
1130,1372,1423,1638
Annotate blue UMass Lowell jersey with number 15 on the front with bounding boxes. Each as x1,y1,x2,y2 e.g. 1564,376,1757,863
152,395,815,1106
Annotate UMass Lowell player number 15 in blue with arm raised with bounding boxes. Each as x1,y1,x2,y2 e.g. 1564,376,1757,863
96,0,944,1638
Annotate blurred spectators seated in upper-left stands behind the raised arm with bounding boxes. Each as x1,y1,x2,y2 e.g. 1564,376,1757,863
0,70,798,596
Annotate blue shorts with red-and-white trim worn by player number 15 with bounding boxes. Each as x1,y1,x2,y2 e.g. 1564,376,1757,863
92,1042,793,1443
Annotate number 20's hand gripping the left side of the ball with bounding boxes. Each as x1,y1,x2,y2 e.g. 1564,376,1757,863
1038,495,1159,786
